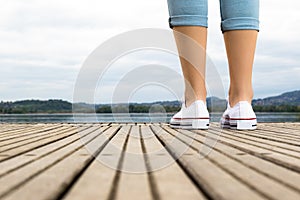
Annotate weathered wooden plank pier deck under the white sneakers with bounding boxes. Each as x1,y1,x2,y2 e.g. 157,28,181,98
0,123,300,200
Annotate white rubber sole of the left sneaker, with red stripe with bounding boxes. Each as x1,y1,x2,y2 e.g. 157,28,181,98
170,118,209,129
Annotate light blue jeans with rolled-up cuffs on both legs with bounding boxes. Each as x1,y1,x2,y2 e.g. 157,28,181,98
168,0,259,32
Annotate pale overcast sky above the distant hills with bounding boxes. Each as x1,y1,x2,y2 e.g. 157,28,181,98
0,0,300,103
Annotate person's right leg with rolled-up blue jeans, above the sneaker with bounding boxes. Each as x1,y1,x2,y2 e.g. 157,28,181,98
220,0,259,106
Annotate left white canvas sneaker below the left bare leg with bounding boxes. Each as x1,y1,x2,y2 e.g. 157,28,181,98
170,100,209,129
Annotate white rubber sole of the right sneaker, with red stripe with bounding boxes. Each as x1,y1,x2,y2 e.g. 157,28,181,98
221,118,257,130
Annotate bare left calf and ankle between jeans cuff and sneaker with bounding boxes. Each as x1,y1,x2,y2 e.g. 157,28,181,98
173,26,207,106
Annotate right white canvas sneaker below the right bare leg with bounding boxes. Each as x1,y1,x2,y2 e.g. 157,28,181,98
221,101,257,130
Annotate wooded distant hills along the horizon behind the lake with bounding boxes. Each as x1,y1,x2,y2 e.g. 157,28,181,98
0,90,300,114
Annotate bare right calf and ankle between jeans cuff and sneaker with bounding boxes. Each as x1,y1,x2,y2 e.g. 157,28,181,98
224,30,257,106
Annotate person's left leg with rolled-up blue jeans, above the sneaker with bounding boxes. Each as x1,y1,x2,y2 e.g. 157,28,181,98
168,0,207,106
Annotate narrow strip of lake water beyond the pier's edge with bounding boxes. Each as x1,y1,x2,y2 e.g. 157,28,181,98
0,113,300,123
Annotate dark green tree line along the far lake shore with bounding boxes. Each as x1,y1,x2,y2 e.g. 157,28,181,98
0,100,300,114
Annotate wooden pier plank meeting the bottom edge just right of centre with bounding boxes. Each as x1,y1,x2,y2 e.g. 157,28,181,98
141,125,206,200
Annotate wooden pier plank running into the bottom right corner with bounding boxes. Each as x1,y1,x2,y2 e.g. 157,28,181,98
166,128,300,200
